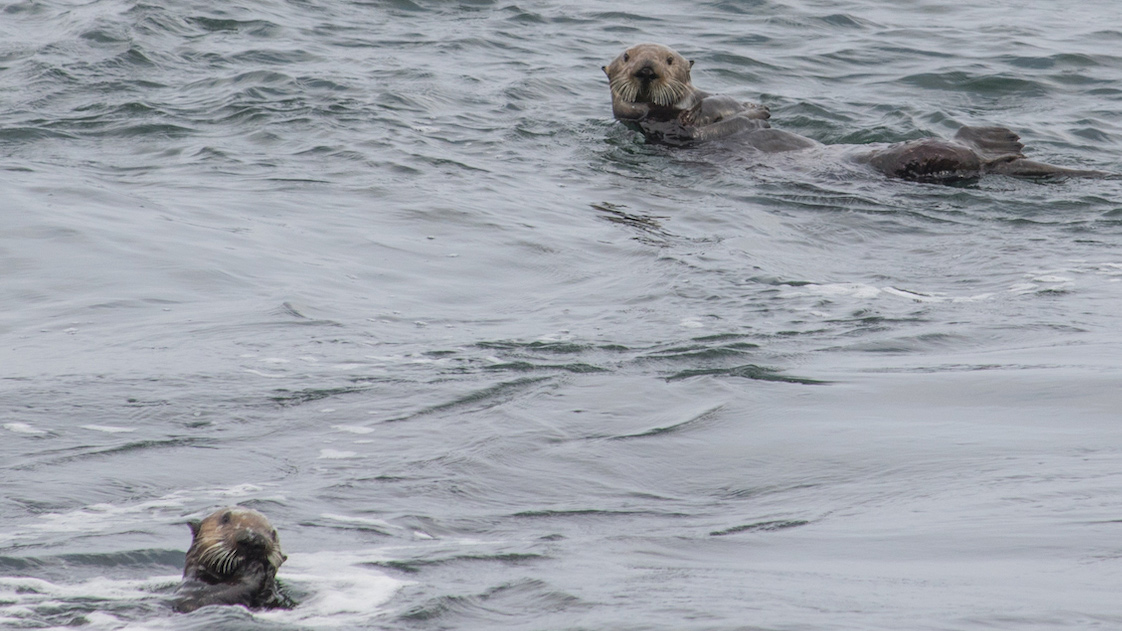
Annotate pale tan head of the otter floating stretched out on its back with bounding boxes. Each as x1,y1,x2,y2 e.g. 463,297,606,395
603,44,693,108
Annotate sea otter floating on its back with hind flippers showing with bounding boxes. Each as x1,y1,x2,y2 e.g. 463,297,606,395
604,44,1105,182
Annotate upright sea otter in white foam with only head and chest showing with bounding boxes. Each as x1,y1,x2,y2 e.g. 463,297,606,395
173,506,295,612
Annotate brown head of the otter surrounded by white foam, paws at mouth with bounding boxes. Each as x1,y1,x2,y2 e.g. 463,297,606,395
183,506,288,583
